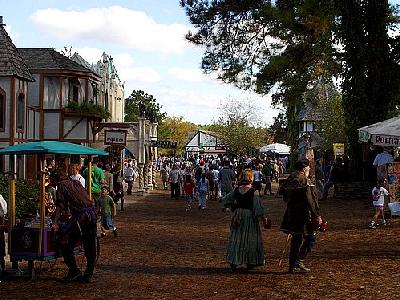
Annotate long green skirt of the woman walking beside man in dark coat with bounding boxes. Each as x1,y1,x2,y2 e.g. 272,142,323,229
226,209,265,266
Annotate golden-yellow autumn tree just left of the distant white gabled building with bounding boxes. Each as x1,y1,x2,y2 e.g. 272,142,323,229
158,117,198,155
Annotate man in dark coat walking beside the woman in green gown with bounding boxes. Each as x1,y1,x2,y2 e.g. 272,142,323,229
281,159,322,273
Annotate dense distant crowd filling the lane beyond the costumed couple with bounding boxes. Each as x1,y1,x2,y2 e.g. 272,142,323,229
157,156,288,209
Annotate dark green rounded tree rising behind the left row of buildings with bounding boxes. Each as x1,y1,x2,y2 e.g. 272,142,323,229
125,90,166,123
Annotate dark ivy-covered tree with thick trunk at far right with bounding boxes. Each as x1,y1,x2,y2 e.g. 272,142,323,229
338,0,399,176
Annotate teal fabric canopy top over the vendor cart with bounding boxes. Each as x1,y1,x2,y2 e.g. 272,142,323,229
0,141,108,155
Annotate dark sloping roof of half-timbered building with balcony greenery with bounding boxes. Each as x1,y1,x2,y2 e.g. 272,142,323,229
18,48,93,73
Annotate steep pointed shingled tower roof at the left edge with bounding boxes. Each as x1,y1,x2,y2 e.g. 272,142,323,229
0,17,35,81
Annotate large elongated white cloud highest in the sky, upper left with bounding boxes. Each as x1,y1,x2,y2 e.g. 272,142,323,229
31,6,189,54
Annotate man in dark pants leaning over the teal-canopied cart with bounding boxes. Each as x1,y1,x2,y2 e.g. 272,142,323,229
53,168,97,282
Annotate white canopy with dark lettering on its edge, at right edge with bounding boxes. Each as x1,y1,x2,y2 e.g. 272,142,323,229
358,116,400,147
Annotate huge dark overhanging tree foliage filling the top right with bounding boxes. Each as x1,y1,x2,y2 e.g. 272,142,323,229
181,0,400,176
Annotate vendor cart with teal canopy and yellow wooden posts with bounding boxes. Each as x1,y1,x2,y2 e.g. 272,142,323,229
0,141,108,276
